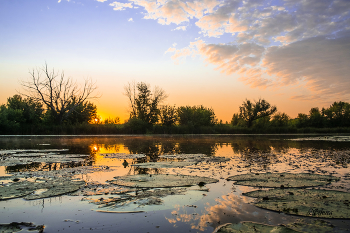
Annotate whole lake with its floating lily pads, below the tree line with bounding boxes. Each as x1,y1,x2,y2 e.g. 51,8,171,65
0,135,350,232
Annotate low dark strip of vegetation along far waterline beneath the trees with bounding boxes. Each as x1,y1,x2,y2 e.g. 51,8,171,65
0,123,350,136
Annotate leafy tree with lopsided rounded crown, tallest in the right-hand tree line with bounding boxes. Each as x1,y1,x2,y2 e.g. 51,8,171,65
239,99,277,127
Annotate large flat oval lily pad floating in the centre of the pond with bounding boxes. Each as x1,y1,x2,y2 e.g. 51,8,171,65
109,174,219,188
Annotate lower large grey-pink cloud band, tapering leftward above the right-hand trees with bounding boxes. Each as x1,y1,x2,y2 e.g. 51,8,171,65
171,30,350,100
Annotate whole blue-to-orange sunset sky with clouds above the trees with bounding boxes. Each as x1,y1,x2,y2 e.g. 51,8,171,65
0,0,350,122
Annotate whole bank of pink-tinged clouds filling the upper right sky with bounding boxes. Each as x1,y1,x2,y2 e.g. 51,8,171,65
103,0,350,99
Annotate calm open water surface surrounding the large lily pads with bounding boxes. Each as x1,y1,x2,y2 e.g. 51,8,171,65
0,135,350,232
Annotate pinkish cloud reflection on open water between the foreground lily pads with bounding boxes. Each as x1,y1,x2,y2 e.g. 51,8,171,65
166,186,296,231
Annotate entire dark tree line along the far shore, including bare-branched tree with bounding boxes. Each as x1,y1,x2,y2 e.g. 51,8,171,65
0,65,350,134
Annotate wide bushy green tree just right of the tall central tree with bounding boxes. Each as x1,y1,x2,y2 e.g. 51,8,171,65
177,105,217,127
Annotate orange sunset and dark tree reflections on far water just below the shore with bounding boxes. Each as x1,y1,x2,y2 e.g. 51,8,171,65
0,136,350,177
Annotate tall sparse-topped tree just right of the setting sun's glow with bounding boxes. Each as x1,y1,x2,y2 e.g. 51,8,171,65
124,82,167,125
